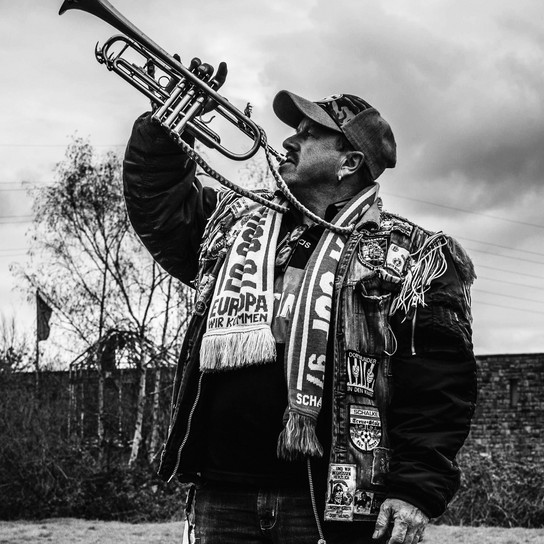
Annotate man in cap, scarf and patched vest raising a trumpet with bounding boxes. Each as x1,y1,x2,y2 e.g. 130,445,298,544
124,61,476,544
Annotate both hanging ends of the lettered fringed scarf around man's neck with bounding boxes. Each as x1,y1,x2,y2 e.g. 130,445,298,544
200,183,379,459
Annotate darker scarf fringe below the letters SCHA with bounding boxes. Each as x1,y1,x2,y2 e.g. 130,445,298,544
277,411,323,461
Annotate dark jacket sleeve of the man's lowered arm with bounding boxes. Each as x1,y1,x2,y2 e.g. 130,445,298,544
388,240,477,517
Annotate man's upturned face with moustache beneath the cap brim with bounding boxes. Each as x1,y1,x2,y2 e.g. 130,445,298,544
279,117,342,188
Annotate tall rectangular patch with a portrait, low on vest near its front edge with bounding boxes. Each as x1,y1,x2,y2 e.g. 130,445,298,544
325,463,357,521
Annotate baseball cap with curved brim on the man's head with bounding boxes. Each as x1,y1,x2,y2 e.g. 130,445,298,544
272,90,397,179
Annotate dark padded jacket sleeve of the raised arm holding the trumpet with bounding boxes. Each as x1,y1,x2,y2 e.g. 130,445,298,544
123,113,216,284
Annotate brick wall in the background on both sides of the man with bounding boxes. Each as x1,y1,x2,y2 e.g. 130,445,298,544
4,353,544,461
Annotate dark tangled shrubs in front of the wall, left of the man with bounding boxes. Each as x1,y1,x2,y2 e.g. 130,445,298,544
0,376,182,522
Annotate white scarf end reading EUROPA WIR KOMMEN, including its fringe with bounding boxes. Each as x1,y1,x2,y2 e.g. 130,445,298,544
200,197,283,371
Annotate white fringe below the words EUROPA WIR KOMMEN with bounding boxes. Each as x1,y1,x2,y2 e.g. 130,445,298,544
200,325,276,371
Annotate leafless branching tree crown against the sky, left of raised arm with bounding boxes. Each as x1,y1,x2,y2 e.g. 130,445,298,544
13,138,191,362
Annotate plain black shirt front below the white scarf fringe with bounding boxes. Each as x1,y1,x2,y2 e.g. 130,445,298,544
202,345,305,484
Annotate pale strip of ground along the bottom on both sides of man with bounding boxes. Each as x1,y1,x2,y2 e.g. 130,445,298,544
0,519,544,544
